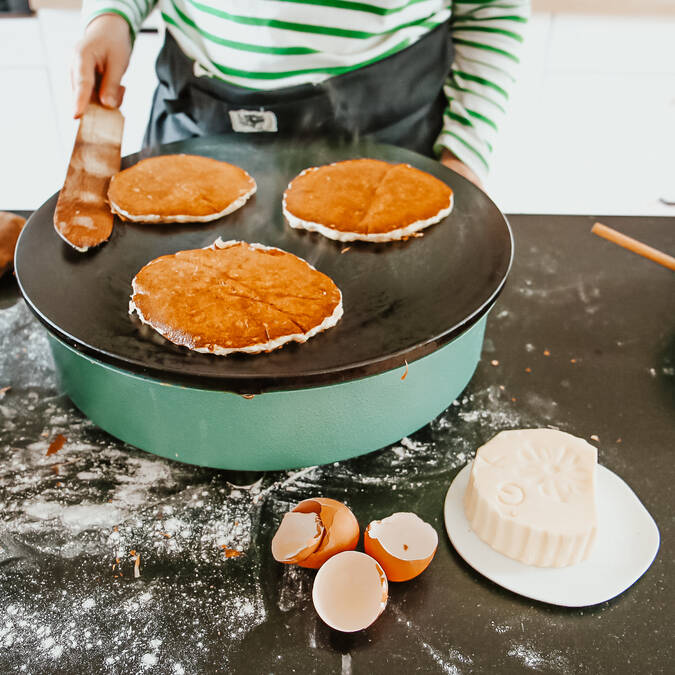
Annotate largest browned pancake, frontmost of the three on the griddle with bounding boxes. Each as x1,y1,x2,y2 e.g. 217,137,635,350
129,239,342,356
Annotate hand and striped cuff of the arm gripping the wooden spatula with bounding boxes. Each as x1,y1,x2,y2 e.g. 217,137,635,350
71,0,156,118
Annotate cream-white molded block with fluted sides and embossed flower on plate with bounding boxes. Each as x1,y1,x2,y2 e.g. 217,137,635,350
464,429,598,567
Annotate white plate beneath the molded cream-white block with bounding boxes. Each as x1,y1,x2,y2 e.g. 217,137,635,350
444,463,660,607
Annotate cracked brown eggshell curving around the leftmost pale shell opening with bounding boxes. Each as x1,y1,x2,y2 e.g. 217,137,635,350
293,497,360,569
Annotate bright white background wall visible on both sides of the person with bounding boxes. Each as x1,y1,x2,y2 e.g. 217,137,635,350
0,10,675,215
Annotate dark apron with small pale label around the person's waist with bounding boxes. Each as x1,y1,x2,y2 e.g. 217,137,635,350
143,22,452,156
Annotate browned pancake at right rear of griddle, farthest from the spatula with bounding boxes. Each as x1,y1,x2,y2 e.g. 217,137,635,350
283,159,453,242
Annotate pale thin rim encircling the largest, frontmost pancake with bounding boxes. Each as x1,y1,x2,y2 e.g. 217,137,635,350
129,237,344,356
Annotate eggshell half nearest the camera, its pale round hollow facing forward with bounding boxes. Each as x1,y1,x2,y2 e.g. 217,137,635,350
312,551,389,633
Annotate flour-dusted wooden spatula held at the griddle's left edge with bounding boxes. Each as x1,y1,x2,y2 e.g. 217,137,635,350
54,103,124,252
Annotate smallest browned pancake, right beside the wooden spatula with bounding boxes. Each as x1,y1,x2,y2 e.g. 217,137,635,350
108,155,256,223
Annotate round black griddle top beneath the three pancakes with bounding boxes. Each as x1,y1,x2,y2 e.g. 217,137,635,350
16,137,512,393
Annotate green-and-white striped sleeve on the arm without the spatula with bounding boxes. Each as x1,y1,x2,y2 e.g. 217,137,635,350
435,0,530,179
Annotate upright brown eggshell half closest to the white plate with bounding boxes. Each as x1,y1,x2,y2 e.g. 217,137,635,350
363,512,438,581
